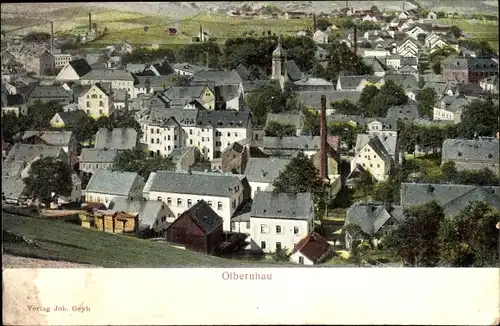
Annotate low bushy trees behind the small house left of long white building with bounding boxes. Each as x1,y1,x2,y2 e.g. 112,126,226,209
113,147,175,179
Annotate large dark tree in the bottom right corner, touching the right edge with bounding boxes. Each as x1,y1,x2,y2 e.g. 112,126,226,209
438,202,500,267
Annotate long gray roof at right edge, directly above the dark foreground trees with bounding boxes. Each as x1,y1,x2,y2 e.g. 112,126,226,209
401,183,500,216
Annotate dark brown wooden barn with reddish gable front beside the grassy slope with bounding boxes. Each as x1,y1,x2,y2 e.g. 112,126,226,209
166,200,224,254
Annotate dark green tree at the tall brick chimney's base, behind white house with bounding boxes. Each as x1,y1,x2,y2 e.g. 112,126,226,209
273,151,326,209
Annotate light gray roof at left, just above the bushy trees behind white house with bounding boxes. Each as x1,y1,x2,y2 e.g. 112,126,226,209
94,128,137,149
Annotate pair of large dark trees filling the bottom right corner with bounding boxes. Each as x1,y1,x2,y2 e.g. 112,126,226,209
385,202,500,267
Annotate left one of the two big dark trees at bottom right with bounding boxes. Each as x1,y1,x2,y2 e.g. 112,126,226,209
386,201,444,267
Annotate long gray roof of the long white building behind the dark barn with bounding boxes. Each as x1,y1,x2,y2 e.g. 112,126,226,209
144,171,241,197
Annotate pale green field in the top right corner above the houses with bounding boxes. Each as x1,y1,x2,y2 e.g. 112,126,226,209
439,18,498,52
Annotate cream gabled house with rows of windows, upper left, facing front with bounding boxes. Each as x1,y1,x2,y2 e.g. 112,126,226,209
78,83,114,119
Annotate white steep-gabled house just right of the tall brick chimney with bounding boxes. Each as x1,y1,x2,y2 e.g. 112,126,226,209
351,134,400,181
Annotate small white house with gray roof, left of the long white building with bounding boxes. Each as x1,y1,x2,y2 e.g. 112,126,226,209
84,170,144,207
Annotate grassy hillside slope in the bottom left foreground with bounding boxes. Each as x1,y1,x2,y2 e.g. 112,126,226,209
2,213,256,268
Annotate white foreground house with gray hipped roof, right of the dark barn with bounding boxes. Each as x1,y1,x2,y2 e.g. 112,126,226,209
250,191,315,253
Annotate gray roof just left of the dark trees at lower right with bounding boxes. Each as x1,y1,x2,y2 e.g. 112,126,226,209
345,203,405,234
